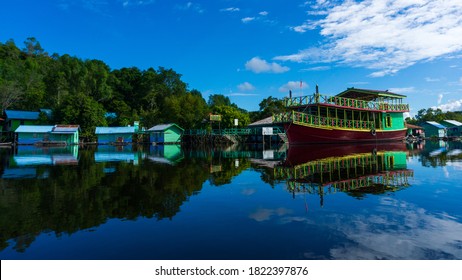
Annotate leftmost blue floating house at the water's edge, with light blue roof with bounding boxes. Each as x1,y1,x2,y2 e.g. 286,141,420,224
15,125,79,145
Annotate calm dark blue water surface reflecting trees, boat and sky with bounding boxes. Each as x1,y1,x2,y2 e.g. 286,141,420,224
0,142,462,260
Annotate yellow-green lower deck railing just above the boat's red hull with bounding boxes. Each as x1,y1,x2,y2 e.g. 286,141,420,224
273,111,375,130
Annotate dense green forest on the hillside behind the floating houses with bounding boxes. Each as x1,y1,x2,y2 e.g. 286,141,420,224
0,37,282,139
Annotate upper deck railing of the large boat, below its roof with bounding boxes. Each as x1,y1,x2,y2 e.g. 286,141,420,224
284,94,409,112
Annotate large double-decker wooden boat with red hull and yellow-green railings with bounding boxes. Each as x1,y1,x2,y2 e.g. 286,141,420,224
273,86,409,145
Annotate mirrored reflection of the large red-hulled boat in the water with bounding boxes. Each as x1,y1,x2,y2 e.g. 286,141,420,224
274,143,414,206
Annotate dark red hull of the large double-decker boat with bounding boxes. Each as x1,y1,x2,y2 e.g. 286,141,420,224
284,123,406,145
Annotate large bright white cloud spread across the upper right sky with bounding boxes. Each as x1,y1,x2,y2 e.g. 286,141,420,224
275,0,462,77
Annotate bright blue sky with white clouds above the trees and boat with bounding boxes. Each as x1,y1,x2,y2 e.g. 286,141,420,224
0,0,462,116
